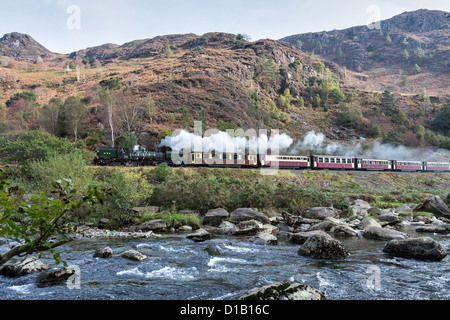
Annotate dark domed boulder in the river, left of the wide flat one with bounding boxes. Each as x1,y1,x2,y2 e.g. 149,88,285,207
298,234,350,259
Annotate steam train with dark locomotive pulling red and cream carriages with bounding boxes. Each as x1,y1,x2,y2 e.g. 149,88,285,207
93,147,450,172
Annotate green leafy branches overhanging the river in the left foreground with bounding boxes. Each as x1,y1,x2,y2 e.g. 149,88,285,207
0,168,104,266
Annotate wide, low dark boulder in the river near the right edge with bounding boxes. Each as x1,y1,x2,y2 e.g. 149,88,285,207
383,237,447,261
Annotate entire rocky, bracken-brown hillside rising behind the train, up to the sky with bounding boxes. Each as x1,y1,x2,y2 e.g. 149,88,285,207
0,12,450,154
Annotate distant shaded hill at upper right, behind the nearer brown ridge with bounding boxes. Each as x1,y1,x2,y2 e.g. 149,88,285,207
281,10,450,95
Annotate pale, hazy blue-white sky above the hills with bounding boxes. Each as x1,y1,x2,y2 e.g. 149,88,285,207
0,0,450,53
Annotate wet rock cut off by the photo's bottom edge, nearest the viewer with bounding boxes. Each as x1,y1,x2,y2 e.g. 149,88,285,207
238,282,326,301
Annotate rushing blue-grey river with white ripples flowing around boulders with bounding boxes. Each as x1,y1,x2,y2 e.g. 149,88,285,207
0,225,450,301
